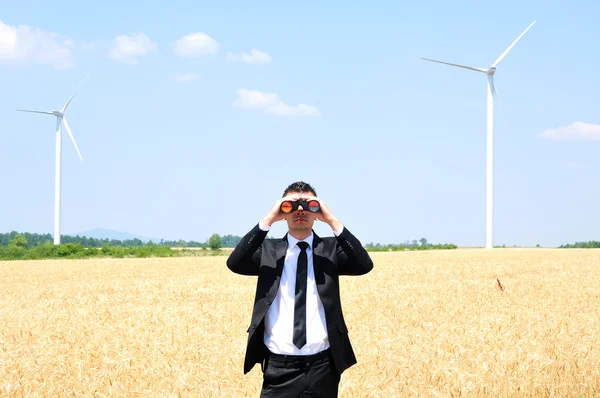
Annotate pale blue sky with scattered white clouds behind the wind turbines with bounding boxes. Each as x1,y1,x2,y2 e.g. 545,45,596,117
0,0,600,246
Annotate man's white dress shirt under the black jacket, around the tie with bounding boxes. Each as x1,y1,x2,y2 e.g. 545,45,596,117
259,224,329,355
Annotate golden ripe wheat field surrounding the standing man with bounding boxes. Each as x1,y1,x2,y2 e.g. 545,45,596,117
0,249,600,397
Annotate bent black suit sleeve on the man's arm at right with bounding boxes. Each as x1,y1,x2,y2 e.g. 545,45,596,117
336,227,373,275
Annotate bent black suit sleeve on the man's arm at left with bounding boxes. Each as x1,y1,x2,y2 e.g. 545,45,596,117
227,224,267,276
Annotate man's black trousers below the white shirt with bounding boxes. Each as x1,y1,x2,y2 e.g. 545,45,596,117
260,350,341,398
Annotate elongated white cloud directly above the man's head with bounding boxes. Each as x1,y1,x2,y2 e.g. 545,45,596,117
233,88,321,116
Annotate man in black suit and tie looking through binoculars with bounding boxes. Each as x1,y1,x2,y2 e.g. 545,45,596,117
227,181,373,397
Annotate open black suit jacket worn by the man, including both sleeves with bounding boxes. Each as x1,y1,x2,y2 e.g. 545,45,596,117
227,224,373,374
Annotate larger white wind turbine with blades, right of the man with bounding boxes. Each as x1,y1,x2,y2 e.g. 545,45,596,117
421,21,536,249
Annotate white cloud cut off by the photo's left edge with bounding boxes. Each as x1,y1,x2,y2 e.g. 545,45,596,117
0,20,75,69
